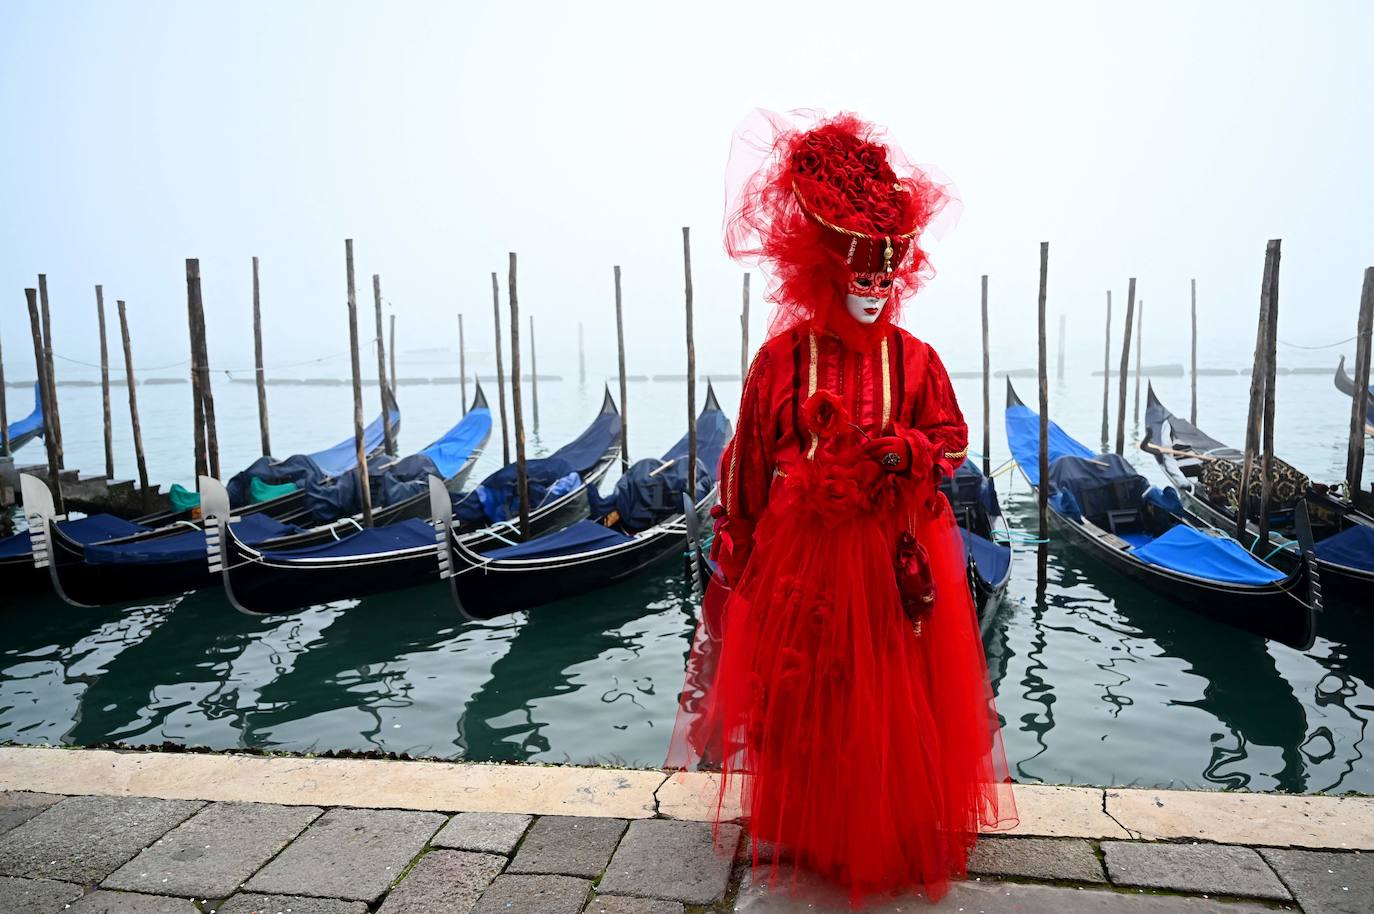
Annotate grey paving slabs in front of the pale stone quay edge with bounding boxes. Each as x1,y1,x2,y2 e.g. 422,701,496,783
0,753,1374,914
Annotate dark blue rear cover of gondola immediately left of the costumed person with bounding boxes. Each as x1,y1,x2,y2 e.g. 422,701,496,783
587,410,730,533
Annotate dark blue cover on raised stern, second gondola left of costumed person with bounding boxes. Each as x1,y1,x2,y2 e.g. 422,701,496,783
453,412,620,529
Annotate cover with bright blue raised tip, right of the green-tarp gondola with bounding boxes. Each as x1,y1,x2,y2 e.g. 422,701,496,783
305,407,492,524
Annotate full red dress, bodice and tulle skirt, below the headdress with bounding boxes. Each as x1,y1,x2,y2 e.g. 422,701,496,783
669,322,1014,903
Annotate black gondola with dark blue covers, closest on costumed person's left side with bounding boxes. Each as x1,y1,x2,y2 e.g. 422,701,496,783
444,385,731,620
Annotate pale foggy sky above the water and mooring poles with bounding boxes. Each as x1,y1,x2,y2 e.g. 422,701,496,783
0,1,1374,379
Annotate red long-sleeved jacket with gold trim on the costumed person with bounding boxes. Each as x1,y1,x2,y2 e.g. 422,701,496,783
712,322,969,581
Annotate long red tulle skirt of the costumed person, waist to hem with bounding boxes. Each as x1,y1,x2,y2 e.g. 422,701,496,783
668,464,1015,904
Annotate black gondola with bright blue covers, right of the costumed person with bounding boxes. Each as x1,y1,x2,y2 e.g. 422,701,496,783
1006,381,1322,650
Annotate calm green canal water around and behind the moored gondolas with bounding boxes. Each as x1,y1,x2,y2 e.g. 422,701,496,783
0,366,1374,792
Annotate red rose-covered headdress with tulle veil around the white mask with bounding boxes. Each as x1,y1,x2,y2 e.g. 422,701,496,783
725,111,955,345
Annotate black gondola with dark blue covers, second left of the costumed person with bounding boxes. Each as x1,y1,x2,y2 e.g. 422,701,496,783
202,390,620,614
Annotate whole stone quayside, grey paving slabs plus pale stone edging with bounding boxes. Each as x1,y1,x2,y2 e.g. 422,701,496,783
0,749,1374,914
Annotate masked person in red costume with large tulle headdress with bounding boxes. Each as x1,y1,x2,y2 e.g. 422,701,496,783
669,114,1014,904
